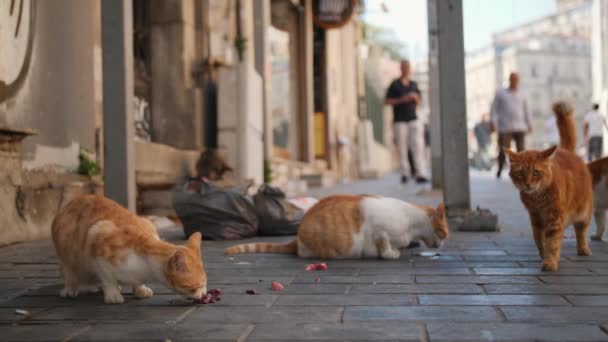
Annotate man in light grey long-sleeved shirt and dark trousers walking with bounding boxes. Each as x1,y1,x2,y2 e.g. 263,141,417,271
490,72,532,178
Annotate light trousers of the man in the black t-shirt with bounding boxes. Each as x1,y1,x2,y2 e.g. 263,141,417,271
393,120,426,176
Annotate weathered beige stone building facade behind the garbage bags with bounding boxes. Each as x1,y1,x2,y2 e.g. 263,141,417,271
0,0,364,243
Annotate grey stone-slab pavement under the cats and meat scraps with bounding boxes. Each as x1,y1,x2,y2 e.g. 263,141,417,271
0,174,608,341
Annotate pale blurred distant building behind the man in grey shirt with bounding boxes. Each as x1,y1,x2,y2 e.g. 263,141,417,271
466,0,592,148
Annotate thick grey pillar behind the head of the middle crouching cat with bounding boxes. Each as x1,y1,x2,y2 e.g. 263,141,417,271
429,0,471,213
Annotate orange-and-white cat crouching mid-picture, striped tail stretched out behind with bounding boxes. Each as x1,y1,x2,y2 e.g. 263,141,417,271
224,195,448,259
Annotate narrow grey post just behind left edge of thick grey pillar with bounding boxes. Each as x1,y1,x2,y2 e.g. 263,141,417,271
427,0,443,189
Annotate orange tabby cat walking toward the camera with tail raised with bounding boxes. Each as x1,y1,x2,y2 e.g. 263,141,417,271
505,103,593,271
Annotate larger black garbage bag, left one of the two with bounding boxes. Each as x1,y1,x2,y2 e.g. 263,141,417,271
173,181,258,240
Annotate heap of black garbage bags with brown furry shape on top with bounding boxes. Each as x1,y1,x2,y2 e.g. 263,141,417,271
173,152,316,240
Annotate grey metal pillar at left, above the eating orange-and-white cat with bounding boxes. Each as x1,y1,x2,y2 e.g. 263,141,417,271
101,0,135,211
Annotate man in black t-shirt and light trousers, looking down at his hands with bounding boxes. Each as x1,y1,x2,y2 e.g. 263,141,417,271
384,61,428,183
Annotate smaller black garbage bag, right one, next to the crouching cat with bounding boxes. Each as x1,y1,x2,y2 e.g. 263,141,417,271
253,184,304,235
